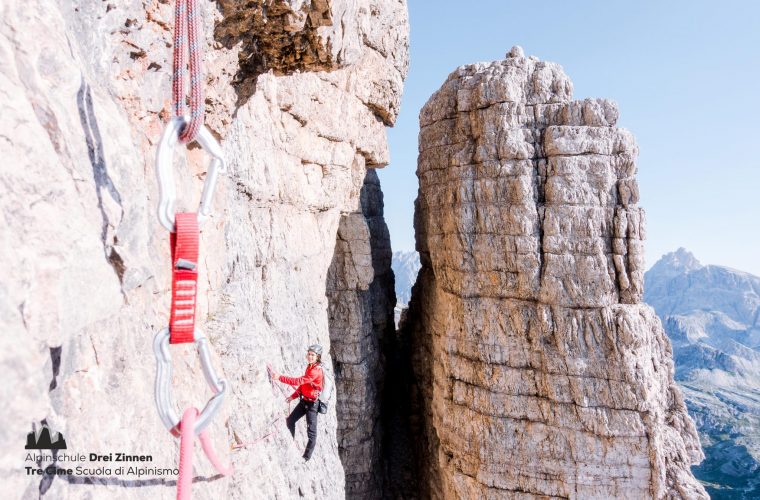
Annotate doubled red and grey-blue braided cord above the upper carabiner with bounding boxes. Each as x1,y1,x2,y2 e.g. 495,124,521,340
172,0,204,143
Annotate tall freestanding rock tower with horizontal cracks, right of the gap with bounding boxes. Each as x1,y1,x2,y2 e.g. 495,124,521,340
404,47,706,498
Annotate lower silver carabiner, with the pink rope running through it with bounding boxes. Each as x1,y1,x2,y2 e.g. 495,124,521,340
153,328,227,437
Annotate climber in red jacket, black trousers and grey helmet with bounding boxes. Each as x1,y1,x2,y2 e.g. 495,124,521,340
267,344,324,462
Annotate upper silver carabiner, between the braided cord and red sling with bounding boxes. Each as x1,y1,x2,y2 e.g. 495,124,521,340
156,116,227,233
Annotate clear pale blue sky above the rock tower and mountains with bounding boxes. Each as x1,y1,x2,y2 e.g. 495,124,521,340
380,0,760,275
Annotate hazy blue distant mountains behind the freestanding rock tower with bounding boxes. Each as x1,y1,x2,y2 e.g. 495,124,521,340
392,248,760,499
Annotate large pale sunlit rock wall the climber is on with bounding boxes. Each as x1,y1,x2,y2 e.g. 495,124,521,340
0,0,408,499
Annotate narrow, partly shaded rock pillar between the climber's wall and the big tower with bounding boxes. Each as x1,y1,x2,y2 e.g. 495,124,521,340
327,170,396,499
